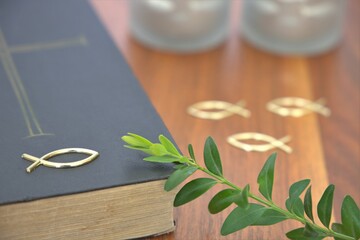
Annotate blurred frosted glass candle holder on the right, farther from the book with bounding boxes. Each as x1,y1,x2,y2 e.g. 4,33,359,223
240,0,347,55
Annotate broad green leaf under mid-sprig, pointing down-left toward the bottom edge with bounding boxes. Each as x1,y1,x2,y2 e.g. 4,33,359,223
221,203,266,236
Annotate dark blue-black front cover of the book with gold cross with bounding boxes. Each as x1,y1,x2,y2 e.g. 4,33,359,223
0,0,171,206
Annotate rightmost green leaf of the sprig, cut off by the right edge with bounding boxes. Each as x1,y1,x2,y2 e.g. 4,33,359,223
341,196,360,239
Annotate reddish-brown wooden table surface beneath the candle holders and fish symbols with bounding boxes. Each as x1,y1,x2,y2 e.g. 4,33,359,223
92,0,360,240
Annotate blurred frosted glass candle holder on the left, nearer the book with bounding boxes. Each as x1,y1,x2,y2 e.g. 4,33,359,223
128,0,230,52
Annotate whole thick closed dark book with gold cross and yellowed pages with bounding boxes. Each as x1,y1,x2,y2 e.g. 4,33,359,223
0,0,174,239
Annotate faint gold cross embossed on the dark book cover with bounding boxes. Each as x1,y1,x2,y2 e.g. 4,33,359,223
0,28,87,137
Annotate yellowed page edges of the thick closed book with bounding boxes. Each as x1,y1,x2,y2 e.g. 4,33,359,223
0,180,174,240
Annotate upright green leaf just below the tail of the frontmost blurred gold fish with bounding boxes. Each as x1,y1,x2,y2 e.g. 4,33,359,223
257,153,276,200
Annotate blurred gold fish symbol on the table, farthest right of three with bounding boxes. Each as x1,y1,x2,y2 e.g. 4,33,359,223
266,97,331,117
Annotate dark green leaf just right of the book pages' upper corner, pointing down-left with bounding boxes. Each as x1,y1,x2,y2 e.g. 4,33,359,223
174,178,217,207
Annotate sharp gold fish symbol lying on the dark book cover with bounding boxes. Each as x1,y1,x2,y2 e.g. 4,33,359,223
21,148,99,173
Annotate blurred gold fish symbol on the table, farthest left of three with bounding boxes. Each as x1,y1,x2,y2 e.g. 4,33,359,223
187,100,250,120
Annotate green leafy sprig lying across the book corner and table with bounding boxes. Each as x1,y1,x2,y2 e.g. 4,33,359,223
122,133,360,240
